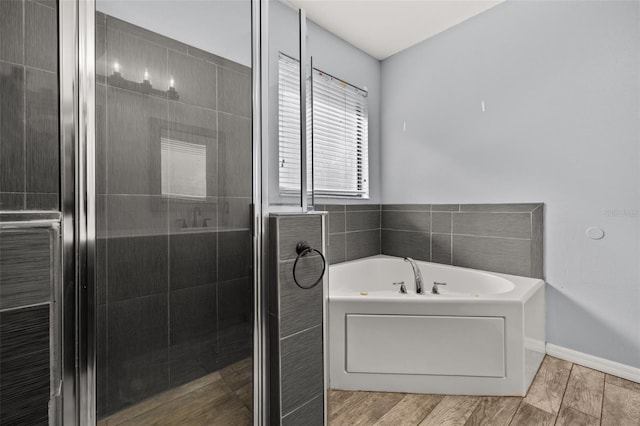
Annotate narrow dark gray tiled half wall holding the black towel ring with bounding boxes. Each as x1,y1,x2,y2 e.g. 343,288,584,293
269,215,328,424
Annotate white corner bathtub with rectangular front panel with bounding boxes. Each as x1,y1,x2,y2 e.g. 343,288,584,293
328,256,545,396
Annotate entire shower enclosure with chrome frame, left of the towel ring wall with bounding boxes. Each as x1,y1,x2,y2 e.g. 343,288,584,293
0,0,265,425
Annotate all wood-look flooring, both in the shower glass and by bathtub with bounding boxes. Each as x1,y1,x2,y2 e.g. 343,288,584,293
98,356,640,426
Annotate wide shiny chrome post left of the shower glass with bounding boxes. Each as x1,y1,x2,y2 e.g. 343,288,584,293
58,0,96,425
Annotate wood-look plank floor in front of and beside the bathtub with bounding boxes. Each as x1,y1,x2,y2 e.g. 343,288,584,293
328,356,640,426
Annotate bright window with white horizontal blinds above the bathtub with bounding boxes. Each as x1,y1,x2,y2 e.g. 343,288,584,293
278,54,369,198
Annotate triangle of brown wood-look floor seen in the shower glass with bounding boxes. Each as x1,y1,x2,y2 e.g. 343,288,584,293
98,358,253,426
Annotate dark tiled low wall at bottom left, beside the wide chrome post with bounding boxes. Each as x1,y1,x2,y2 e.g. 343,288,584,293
0,223,59,425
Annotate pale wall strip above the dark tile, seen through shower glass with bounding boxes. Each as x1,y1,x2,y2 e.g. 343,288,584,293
96,0,251,67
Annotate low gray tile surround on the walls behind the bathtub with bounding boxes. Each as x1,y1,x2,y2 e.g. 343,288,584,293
318,203,544,278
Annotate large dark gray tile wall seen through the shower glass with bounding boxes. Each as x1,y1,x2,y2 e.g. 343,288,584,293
95,13,253,417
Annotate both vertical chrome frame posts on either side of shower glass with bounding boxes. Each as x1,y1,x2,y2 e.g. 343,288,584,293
58,0,268,426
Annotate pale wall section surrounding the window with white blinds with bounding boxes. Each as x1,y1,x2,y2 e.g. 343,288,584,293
265,0,380,205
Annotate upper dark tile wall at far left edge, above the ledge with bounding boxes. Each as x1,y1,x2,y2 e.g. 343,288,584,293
0,0,59,210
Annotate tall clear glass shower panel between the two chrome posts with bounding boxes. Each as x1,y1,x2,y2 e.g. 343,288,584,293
95,0,254,424
